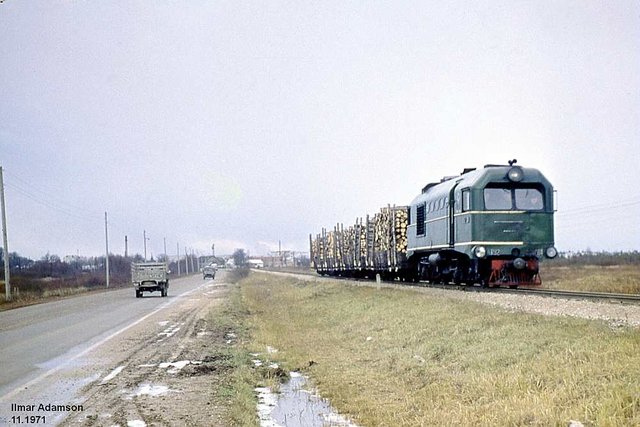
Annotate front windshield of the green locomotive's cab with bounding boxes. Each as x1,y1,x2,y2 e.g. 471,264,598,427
484,185,544,211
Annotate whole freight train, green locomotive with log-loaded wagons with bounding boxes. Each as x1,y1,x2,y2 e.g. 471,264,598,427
310,160,558,288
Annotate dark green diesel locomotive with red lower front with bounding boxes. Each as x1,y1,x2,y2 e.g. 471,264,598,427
407,160,558,287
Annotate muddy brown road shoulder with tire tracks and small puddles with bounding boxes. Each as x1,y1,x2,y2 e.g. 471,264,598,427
61,283,227,427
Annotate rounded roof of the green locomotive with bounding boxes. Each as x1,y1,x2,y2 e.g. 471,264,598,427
411,165,551,205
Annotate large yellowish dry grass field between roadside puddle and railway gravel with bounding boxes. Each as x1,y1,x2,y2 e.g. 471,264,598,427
241,274,640,426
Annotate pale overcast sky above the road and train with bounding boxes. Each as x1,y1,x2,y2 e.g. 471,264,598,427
0,0,640,259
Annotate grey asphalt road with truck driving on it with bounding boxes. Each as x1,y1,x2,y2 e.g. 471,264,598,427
0,274,205,401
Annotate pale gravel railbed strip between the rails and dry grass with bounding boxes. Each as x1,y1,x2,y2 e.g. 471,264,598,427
258,273,640,328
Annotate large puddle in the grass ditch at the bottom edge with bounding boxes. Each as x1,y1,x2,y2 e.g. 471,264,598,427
255,372,357,427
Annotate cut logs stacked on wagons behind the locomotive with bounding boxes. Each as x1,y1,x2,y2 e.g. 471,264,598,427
310,206,409,269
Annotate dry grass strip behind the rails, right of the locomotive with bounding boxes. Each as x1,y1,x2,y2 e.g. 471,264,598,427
540,264,640,294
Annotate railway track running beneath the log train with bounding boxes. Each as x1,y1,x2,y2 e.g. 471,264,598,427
262,271,640,304
